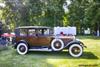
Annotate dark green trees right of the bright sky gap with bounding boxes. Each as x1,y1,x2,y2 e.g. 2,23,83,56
68,0,100,35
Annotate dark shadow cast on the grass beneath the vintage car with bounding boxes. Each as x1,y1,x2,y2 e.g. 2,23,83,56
27,51,99,60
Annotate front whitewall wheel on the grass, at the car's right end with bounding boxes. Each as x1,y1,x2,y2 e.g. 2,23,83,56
69,44,83,57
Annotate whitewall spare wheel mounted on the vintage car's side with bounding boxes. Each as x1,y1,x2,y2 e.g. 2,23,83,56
51,39,64,51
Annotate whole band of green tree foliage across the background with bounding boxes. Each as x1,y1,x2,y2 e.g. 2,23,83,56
0,0,100,34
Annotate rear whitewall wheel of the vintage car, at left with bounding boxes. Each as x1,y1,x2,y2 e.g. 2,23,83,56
17,43,28,55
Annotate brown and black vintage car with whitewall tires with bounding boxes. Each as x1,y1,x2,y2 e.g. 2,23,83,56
13,26,84,57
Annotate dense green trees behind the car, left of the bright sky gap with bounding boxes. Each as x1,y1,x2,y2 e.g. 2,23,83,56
2,0,67,29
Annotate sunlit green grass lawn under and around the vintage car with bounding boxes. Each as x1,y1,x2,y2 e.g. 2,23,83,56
0,36,100,67
